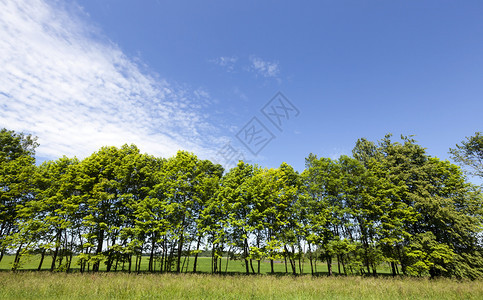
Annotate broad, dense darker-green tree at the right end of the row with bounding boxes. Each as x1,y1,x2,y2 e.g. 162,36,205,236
357,135,483,278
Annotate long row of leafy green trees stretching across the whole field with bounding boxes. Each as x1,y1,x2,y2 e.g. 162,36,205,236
0,129,483,279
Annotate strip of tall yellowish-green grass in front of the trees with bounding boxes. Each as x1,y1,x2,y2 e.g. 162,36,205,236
0,271,483,300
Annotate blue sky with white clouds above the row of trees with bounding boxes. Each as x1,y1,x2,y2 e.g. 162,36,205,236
0,0,483,176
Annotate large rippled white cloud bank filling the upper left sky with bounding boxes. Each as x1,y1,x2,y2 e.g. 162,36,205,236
0,0,223,159
